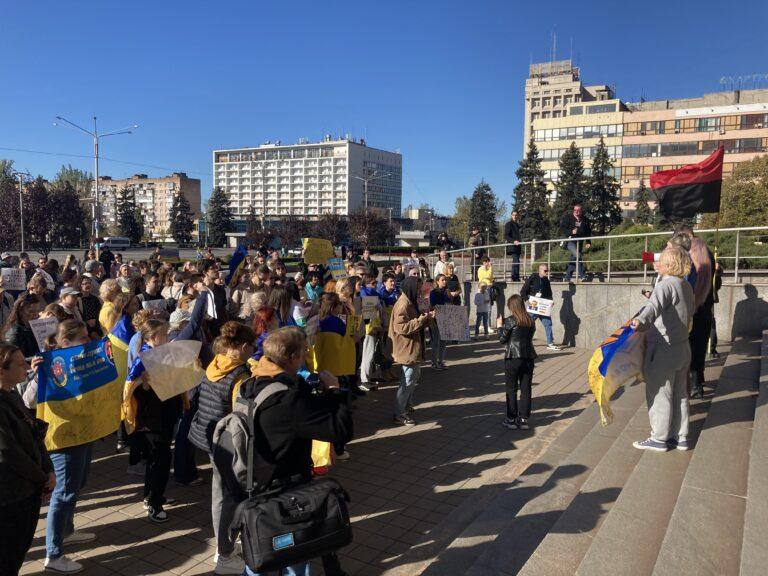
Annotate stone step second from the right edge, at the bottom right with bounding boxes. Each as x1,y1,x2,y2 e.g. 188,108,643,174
648,339,762,576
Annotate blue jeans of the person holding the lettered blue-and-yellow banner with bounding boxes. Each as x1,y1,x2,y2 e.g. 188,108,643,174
45,443,92,559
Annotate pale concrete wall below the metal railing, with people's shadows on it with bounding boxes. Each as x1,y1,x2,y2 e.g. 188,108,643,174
464,282,768,348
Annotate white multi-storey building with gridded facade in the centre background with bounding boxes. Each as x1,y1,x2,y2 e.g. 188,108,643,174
213,136,403,219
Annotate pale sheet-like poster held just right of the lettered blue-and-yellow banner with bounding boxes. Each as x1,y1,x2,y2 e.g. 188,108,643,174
139,340,204,401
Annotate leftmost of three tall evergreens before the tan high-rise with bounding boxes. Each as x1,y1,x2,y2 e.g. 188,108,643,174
513,138,551,240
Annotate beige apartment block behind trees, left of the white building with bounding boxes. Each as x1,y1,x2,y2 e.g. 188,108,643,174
94,172,200,239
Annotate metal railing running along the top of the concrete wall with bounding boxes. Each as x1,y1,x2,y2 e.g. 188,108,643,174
427,226,768,283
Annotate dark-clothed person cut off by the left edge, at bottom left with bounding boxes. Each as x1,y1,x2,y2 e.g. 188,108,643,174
0,343,56,575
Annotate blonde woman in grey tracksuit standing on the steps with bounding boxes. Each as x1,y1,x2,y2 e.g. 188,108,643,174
632,246,693,452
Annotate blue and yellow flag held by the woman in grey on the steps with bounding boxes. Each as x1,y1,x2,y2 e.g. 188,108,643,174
587,321,645,426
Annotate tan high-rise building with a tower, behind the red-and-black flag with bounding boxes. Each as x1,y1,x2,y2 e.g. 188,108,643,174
523,60,768,217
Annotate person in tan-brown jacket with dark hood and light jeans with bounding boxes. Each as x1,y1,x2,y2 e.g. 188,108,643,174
389,277,435,426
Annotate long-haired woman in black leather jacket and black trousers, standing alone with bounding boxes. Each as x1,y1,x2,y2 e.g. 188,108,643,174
496,294,536,430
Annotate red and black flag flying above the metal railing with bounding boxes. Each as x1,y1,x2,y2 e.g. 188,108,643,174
651,146,724,218
